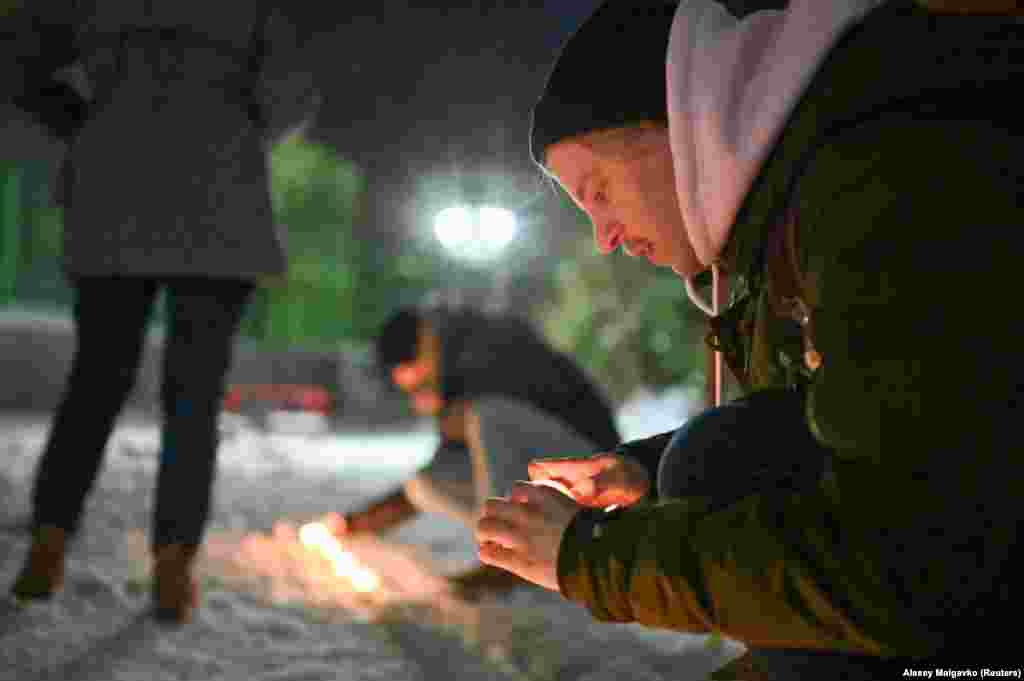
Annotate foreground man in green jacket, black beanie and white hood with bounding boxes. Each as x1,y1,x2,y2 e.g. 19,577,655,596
477,0,1024,673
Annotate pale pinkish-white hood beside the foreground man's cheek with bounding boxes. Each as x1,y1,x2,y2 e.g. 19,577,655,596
666,0,884,266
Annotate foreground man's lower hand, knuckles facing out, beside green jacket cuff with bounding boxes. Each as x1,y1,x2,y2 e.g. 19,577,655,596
476,482,580,592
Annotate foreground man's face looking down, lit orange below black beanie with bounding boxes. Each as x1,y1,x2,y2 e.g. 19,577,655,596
546,127,705,279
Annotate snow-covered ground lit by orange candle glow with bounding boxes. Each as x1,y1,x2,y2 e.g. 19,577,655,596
0,395,736,681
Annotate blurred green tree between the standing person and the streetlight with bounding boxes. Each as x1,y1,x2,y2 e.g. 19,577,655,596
252,135,440,349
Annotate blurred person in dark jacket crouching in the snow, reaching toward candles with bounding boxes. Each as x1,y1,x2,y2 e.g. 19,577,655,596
329,307,621,596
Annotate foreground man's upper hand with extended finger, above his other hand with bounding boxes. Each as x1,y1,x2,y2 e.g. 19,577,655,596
528,453,650,508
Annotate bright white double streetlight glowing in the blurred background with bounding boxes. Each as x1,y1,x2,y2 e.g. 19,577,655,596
434,201,518,263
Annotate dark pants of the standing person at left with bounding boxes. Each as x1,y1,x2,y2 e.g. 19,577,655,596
33,276,253,546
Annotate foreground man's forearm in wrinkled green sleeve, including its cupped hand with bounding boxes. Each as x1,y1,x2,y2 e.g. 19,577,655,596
477,483,901,654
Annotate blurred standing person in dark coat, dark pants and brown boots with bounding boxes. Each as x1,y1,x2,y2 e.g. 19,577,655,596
9,0,316,623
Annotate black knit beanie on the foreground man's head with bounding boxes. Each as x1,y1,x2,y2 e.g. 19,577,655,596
530,0,678,166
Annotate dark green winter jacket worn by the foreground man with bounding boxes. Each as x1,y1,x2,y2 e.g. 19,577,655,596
558,2,1024,657
